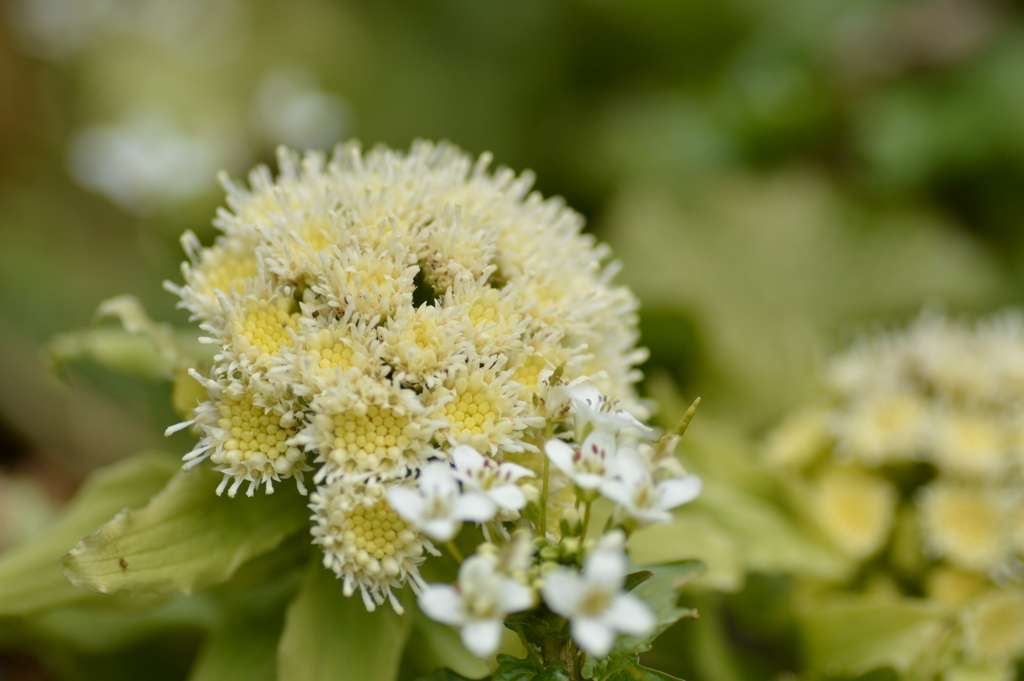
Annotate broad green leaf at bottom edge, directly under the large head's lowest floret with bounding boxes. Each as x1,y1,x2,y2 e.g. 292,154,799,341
278,560,413,681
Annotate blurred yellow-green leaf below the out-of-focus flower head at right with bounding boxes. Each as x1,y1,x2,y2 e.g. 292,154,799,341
799,595,955,678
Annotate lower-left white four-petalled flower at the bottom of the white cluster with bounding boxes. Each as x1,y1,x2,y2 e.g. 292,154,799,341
419,554,535,657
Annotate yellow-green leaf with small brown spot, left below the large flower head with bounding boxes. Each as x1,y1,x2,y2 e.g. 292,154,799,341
60,467,308,594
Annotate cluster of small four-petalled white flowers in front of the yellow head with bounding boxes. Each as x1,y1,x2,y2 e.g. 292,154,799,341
407,379,700,657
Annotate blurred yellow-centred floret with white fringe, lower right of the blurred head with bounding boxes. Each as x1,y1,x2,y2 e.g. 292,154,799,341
921,482,1007,571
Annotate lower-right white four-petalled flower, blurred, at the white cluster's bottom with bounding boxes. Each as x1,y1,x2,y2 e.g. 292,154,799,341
541,529,655,657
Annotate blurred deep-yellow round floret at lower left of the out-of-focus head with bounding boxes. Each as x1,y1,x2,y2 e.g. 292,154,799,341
811,467,896,559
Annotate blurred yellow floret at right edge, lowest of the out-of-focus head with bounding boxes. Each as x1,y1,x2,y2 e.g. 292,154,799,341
963,589,1024,661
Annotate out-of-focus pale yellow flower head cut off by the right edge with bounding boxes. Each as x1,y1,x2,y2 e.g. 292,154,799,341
767,311,1024,659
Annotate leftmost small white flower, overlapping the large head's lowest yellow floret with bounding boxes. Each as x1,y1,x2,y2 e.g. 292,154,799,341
387,462,498,542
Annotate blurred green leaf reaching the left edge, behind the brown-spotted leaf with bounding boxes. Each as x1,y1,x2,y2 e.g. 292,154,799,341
0,453,180,618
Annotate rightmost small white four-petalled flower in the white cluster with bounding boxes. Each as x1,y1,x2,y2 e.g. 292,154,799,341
601,449,701,522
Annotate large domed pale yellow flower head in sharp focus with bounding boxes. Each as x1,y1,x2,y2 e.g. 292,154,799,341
168,142,644,608
